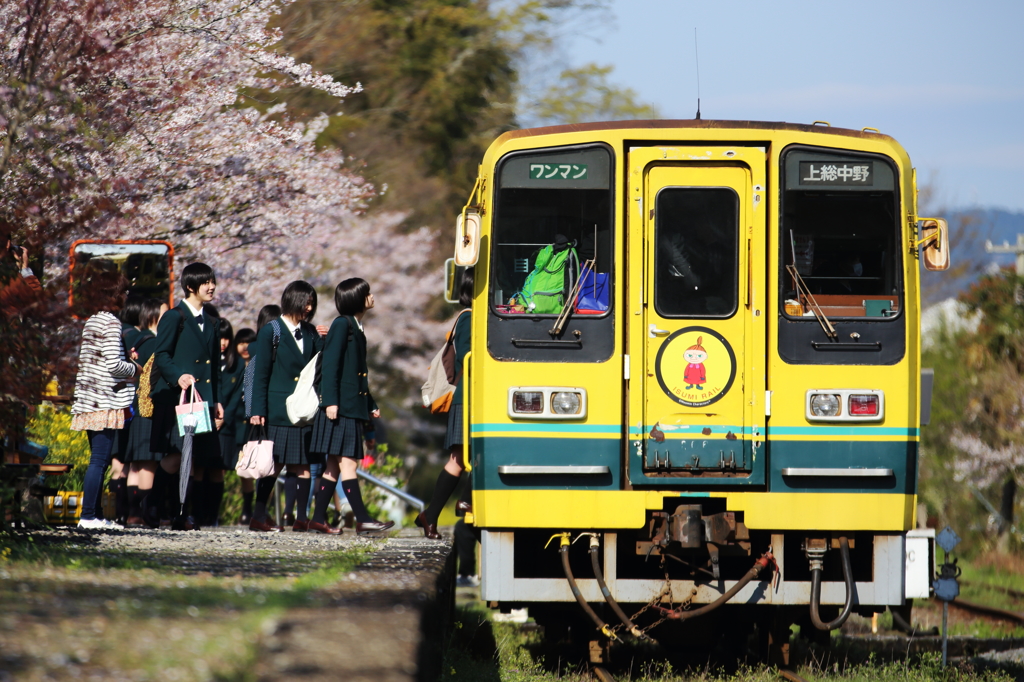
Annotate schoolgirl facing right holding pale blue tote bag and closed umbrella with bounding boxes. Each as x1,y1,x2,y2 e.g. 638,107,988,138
150,263,224,530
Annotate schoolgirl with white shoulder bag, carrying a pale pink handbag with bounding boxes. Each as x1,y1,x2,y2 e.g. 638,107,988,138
249,281,324,532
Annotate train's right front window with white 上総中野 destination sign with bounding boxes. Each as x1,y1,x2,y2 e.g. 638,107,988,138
779,147,903,317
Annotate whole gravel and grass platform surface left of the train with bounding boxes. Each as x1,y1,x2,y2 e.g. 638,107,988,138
0,522,451,682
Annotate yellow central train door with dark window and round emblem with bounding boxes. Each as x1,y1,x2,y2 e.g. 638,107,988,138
630,147,766,486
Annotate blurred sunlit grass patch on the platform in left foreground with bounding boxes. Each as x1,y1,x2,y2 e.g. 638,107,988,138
0,536,373,682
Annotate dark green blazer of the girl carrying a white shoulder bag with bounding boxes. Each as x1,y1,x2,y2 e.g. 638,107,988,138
249,317,324,426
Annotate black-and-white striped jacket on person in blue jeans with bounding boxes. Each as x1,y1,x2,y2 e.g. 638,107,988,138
71,312,135,415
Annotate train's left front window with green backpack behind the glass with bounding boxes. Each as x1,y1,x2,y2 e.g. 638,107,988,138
490,145,612,316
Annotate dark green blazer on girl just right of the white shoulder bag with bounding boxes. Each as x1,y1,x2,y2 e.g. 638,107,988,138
321,315,377,421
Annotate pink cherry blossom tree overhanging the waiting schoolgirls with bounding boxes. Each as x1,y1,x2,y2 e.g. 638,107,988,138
0,0,446,444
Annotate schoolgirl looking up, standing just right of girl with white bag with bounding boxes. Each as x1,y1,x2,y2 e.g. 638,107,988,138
309,278,394,536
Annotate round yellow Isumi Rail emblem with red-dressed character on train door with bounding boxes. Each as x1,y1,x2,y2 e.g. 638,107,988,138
654,327,736,408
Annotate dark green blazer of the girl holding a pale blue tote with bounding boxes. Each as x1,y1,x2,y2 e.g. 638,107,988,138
153,301,220,405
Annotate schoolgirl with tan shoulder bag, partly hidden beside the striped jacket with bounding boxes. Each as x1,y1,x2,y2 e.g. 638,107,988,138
125,298,167,527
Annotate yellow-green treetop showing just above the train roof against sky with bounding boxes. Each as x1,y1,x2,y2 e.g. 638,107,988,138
534,62,660,124
